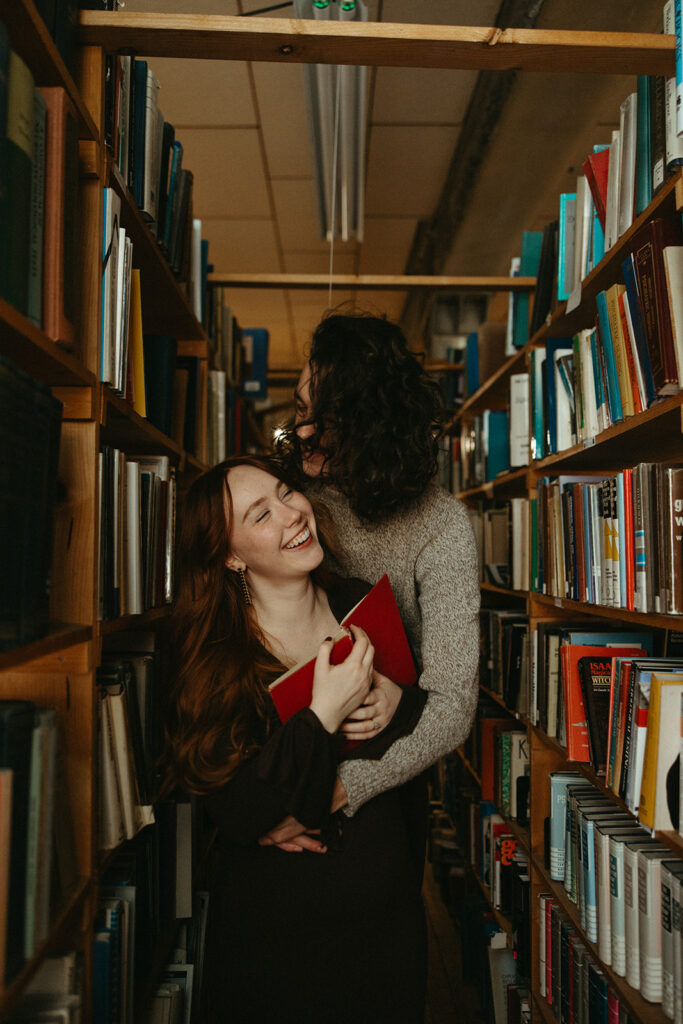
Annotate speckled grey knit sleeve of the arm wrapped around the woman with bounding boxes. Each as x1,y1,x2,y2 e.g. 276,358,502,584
339,505,479,815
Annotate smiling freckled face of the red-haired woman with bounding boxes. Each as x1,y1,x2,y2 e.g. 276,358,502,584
225,466,323,581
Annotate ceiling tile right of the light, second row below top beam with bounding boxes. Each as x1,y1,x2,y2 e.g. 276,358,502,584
366,127,459,217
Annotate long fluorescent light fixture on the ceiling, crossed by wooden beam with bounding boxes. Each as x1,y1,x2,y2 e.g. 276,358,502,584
294,0,368,242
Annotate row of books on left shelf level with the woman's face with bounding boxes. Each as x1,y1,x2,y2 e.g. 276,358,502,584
98,445,176,618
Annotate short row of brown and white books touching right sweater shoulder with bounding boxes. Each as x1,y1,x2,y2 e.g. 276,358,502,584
468,498,536,591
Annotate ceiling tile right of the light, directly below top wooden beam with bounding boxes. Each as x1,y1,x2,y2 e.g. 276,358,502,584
372,68,477,124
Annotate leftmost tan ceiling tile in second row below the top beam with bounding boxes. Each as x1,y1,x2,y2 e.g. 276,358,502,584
180,128,270,217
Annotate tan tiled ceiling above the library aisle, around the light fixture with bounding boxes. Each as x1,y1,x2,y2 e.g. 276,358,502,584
126,0,661,367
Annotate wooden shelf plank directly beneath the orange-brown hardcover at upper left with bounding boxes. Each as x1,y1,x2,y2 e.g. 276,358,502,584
0,299,95,387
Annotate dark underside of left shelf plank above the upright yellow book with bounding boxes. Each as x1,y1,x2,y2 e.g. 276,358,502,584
106,157,207,341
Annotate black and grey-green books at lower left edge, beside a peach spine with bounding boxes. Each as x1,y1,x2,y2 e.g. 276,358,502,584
0,699,77,980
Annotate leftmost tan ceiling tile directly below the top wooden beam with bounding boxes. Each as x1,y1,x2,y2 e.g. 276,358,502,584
150,57,257,128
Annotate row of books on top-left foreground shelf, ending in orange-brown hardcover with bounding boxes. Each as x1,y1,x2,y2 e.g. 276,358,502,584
0,29,79,348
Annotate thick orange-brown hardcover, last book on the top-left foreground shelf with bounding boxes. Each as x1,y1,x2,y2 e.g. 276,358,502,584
40,87,79,347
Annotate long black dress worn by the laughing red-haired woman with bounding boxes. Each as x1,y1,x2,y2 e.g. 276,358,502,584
203,581,426,1024
